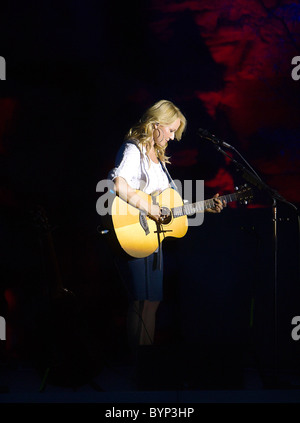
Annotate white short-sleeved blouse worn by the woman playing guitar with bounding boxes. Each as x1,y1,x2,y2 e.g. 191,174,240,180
109,141,170,194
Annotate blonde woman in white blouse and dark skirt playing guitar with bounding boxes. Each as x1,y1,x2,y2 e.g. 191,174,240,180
110,100,223,354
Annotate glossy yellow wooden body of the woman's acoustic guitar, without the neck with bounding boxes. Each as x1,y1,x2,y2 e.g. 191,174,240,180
107,188,188,258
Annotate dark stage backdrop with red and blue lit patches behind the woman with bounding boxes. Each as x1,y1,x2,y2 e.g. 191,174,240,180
0,0,300,387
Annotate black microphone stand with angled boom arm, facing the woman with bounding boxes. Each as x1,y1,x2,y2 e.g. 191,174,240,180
199,129,300,388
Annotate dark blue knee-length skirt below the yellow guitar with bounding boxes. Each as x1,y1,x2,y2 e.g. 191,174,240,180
116,251,163,301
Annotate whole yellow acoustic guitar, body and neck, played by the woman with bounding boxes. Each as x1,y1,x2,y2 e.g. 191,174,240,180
102,186,253,258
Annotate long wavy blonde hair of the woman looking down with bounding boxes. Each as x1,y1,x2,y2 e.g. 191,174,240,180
125,100,187,163
